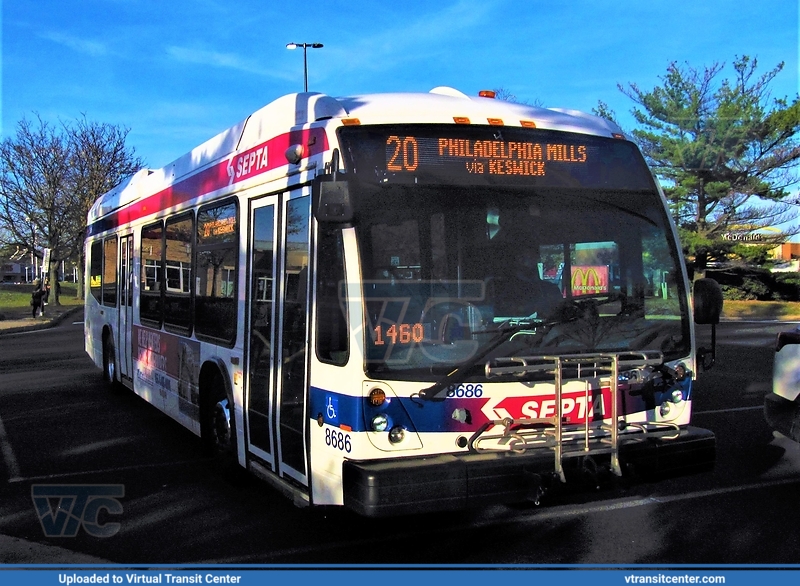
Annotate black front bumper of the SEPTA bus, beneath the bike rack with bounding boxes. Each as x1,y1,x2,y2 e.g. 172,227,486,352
343,427,716,517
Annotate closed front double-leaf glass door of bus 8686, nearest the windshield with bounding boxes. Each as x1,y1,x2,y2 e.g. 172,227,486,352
247,194,311,484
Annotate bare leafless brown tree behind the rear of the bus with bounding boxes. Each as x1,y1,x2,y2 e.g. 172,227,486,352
0,116,142,303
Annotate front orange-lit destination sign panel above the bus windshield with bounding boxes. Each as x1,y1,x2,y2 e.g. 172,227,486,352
339,124,653,189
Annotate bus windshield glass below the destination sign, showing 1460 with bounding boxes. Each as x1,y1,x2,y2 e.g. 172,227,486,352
338,126,690,380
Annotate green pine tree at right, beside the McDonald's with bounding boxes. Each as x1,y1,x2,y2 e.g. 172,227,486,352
594,56,800,276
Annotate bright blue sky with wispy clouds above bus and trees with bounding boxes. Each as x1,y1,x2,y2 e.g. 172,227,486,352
2,0,798,167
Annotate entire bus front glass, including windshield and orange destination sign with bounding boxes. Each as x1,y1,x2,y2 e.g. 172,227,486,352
340,125,690,380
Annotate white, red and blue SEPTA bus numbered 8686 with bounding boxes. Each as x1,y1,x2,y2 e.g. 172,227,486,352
85,87,721,516
